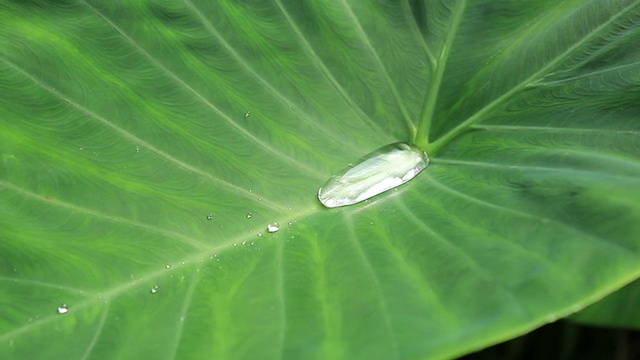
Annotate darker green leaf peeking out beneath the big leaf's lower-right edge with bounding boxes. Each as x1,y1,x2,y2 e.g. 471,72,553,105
569,280,640,329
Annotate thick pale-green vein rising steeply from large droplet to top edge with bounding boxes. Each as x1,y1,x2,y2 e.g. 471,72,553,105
413,0,467,153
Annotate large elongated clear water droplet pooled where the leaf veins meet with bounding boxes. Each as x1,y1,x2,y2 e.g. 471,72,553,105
318,143,429,208
